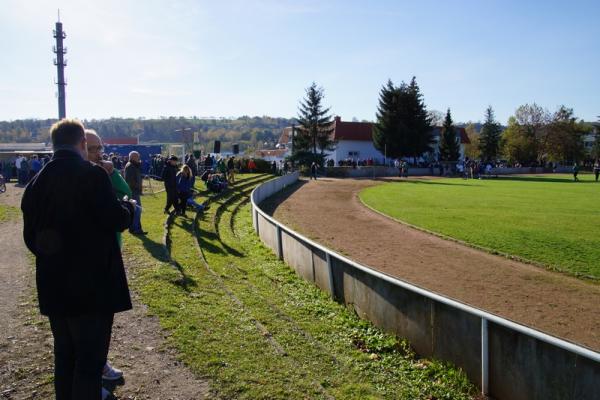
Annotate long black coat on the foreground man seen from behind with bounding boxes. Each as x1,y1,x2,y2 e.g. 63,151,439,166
21,150,133,316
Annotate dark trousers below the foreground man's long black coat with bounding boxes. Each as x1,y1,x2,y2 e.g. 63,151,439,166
50,314,113,400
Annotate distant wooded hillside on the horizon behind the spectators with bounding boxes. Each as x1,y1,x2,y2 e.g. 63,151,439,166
0,116,293,155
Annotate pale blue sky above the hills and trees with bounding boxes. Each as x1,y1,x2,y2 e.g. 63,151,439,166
0,0,600,123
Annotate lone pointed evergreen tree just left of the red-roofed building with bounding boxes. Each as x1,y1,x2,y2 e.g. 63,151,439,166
294,82,335,163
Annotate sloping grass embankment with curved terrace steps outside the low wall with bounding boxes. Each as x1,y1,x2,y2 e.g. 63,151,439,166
125,175,475,399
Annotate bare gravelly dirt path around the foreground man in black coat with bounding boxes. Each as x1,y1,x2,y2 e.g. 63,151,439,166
0,184,209,400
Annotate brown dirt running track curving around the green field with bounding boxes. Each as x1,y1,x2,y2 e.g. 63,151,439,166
264,179,600,351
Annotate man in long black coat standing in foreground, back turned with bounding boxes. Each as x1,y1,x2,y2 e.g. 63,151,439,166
21,120,133,400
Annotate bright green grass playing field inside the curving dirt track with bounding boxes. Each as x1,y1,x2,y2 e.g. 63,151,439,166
360,175,600,279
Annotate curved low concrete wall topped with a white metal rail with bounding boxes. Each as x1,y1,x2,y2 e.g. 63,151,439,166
251,172,600,400
